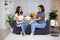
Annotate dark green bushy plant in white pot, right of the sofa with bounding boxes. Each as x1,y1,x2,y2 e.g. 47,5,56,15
49,10,58,26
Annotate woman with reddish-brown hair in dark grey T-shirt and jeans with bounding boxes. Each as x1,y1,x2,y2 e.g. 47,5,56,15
31,5,46,35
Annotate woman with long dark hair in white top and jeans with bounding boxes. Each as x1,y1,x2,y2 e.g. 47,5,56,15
15,6,28,35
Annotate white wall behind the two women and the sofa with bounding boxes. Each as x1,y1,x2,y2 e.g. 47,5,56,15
0,0,51,29
